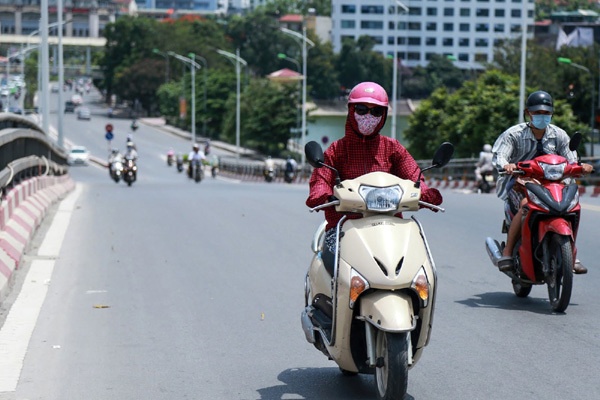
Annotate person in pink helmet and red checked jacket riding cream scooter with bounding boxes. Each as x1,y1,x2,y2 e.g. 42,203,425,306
306,82,442,269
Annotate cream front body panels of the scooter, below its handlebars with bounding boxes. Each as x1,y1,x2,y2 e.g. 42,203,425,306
308,215,437,371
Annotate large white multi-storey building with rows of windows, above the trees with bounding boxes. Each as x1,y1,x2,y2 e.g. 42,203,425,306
331,0,535,69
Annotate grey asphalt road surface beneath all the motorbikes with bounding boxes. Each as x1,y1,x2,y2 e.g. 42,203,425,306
0,88,600,400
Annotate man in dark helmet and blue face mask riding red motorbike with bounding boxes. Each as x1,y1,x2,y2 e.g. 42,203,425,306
492,90,593,274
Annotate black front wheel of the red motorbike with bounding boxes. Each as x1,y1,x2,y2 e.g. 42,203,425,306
546,234,573,312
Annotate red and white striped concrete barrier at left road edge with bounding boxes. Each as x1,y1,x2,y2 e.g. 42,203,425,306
0,175,75,300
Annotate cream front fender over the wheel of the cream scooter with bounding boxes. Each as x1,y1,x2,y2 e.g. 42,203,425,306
358,290,417,332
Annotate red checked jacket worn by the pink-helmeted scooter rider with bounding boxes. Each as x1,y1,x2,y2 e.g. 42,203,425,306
306,122,442,229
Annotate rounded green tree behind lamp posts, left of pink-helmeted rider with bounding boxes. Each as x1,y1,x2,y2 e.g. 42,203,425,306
223,79,298,155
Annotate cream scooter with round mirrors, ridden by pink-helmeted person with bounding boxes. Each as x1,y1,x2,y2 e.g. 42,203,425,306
301,142,454,400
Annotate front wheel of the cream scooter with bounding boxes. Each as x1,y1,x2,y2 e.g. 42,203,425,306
375,330,408,400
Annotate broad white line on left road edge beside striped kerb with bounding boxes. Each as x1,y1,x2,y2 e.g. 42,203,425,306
0,184,81,393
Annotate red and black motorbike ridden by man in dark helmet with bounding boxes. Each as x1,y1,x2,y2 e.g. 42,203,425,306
486,133,583,312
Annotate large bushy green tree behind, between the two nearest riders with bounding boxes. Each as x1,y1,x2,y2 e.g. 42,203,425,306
404,70,584,158
